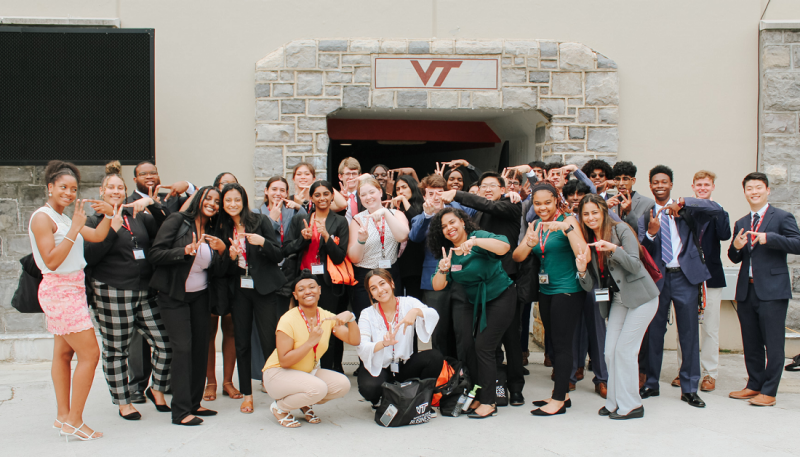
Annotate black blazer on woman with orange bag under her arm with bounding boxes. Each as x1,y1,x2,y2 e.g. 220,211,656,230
282,211,350,285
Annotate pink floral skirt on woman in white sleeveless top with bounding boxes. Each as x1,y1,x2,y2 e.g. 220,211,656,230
39,270,94,335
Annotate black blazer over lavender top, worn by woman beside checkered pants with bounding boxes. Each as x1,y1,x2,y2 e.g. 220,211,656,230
149,212,223,306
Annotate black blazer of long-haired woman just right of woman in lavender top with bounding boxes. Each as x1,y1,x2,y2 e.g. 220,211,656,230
221,213,286,295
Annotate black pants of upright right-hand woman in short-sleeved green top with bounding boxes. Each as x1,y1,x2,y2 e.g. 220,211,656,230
539,291,586,401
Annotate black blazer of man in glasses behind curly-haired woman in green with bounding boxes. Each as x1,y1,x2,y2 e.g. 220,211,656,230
455,190,522,278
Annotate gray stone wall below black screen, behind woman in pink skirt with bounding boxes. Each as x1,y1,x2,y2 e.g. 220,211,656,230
0,166,104,361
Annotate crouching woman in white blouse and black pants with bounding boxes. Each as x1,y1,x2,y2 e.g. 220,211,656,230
358,268,444,405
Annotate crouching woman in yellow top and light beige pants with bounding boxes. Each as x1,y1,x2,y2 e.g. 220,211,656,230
263,270,361,428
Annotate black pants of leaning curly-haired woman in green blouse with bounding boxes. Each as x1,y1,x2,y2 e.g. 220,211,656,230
451,284,516,404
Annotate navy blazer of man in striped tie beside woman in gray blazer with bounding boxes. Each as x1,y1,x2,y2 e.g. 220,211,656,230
637,198,724,291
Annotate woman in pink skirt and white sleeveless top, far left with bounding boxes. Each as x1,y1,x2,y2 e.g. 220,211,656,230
28,160,118,441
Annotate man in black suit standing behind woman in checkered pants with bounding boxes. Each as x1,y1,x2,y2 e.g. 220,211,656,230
125,162,195,403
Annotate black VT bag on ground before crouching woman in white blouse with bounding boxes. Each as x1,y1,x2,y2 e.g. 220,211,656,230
375,378,436,427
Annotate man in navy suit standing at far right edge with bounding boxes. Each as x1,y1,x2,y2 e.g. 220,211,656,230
728,173,800,406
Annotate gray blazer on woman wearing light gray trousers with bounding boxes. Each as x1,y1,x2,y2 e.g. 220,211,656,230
578,224,658,317
